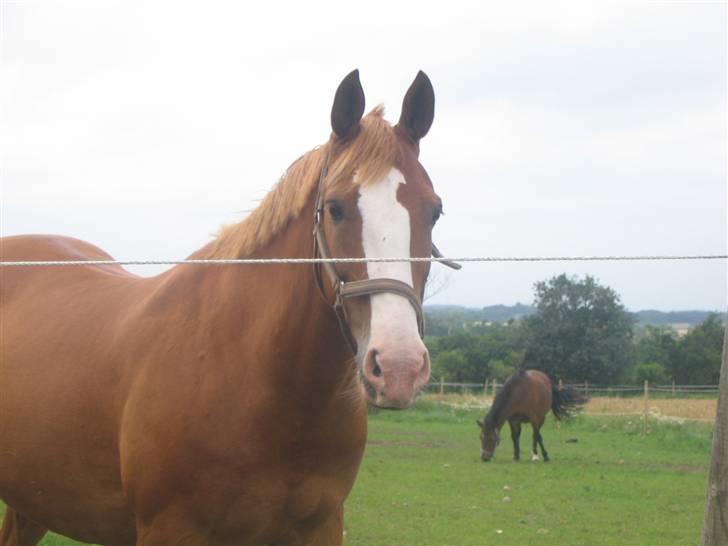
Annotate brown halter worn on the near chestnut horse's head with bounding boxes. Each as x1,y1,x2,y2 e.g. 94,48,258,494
313,150,461,354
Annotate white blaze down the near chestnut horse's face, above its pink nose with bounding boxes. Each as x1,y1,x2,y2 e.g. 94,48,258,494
359,169,419,342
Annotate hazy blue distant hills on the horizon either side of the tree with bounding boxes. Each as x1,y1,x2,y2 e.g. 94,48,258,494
425,303,725,326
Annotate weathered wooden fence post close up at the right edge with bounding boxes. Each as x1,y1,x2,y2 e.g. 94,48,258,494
700,323,728,546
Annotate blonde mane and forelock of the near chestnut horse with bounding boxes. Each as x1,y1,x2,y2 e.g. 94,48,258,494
202,106,399,259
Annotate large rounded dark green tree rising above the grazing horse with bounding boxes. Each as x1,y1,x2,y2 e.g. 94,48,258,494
525,275,634,383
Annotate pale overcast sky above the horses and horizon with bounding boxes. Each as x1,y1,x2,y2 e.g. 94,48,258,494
0,0,727,310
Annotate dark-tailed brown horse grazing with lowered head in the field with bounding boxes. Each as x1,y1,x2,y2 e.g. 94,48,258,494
476,370,587,462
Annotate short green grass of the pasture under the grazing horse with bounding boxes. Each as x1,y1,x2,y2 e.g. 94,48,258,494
1,400,711,546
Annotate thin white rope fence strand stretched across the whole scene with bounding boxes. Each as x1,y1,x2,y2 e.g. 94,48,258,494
0,254,728,267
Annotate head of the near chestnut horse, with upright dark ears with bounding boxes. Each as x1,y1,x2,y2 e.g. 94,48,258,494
317,71,442,408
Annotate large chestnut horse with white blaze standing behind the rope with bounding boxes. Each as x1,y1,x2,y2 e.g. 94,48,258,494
0,71,442,546
